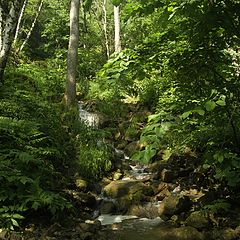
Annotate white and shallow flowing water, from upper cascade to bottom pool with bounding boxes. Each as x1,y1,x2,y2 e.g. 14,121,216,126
79,102,172,240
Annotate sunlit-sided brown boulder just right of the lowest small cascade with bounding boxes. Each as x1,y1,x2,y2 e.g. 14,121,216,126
159,195,192,216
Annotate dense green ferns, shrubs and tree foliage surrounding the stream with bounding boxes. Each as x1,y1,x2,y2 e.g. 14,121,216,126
0,0,240,234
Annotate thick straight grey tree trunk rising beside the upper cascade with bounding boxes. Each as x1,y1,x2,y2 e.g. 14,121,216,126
64,0,80,106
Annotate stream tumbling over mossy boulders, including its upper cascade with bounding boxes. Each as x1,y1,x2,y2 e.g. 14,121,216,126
79,102,208,240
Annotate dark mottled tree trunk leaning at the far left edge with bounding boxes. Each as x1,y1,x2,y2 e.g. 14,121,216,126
0,0,22,84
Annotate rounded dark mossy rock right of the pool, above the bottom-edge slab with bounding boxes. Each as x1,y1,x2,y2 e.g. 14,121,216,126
185,211,211,229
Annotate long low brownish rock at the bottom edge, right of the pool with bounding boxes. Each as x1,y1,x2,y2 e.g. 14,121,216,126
153,226,204,240
